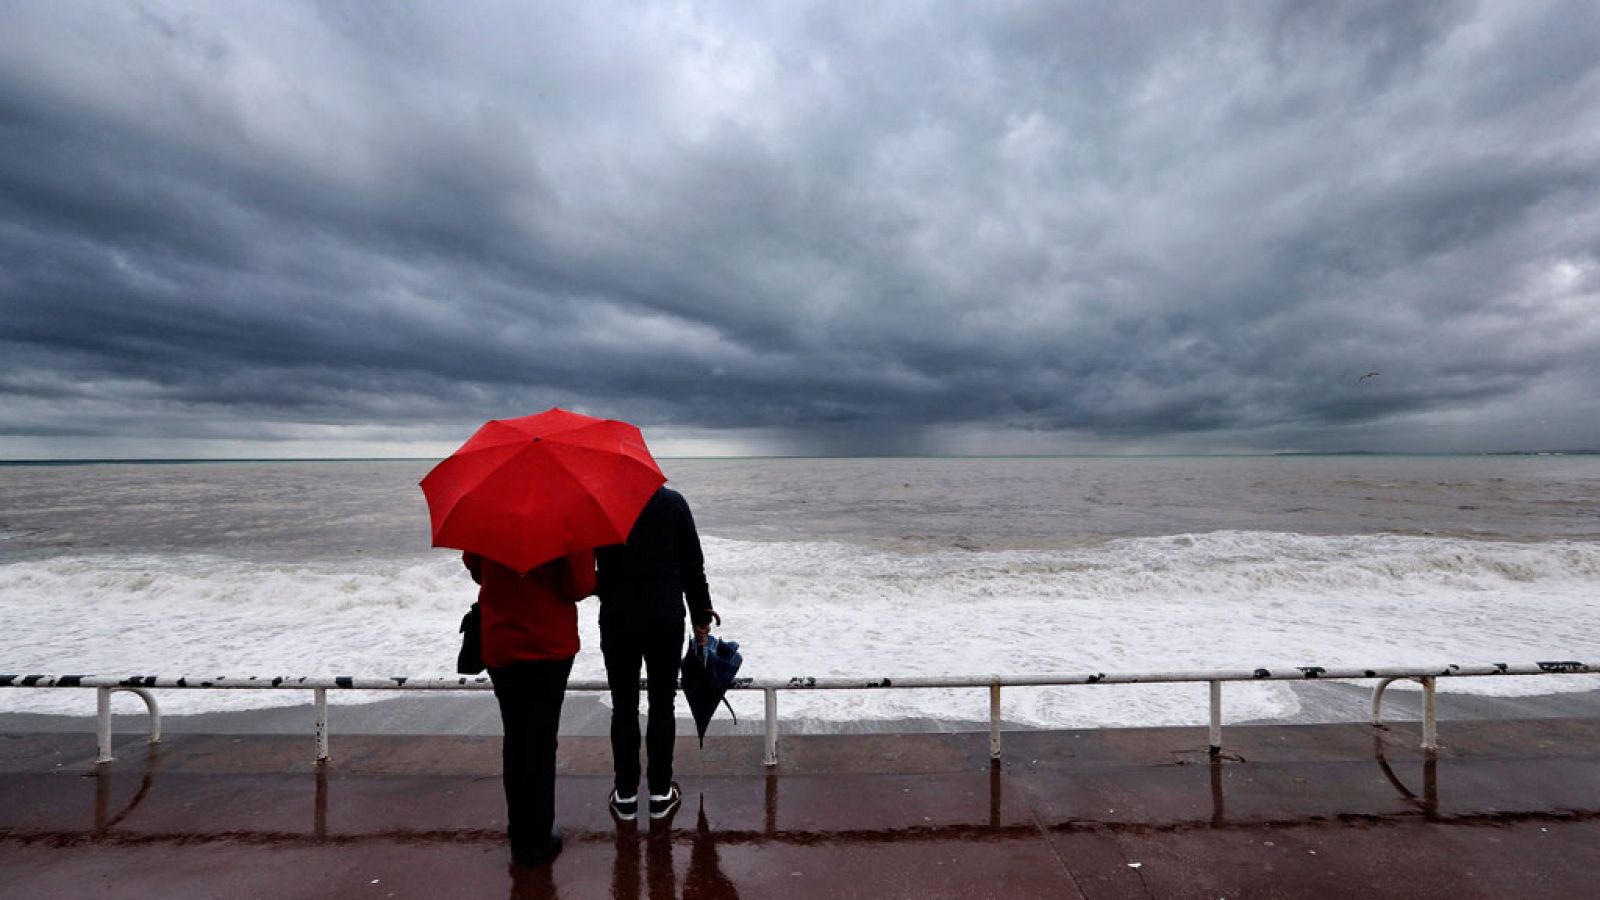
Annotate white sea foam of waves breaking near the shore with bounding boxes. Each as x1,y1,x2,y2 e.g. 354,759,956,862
0,532,1600,727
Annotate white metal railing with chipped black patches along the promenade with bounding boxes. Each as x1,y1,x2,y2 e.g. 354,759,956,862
0,660,1600,765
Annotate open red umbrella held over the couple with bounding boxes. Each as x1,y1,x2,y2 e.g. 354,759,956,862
422,410,667,572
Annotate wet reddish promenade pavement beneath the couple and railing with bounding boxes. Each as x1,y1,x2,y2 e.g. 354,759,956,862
0,719,1600,898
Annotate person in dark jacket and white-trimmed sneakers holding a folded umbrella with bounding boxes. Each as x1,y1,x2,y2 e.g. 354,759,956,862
595,487,722,822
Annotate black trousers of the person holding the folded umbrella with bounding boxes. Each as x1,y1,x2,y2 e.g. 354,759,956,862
600,620,683,798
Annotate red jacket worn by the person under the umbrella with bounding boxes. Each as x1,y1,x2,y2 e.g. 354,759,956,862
461,551,595,666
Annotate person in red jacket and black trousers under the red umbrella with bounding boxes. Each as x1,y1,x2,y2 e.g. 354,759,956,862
461,551,595,866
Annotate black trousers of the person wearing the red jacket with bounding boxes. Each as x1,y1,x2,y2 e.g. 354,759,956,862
490,658,573,855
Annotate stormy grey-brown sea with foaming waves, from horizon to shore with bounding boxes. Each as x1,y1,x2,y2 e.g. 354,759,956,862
0,456,1600,727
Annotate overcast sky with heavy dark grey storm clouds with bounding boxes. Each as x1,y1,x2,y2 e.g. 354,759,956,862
0,0,1600,458
